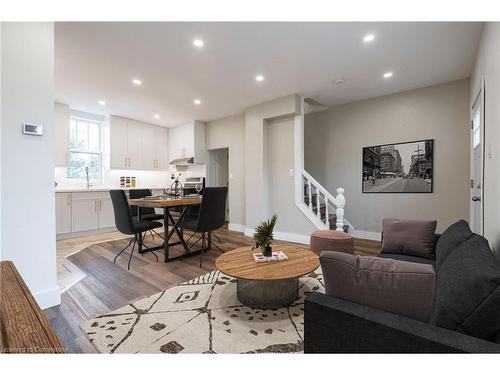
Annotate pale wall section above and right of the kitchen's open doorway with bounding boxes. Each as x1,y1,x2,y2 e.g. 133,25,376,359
205,113,245,230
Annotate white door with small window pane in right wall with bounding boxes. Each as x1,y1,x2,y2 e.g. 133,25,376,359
470,86,484,235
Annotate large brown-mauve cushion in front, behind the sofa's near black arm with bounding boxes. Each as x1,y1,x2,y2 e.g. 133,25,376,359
320,251,435,322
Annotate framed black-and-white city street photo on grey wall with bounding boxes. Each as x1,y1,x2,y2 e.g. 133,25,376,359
362,139,434,193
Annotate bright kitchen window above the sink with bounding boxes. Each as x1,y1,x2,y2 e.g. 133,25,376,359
67,117,102,183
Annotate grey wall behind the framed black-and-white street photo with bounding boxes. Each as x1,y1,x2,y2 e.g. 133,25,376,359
304,77,470,232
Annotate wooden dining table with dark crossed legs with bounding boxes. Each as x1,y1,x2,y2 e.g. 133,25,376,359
128,195,203,262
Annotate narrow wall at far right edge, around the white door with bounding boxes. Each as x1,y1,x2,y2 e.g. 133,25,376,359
469,22,500,259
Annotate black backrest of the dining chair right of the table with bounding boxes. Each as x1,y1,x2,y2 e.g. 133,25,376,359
197,186,227,232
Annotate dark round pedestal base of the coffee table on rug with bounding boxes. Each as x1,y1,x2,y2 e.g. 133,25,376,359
236,278,299,309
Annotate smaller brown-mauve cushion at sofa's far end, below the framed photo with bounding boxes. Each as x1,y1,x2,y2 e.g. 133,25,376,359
382,219,437,259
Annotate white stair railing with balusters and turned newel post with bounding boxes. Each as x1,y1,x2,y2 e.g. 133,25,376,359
300,170,352,231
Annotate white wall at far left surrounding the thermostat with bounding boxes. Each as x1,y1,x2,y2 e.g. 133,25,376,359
1,23,60,308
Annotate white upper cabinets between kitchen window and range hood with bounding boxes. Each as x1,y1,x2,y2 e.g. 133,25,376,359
110,116,168,170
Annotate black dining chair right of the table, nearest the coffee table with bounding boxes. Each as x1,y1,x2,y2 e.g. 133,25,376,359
181,186,227,267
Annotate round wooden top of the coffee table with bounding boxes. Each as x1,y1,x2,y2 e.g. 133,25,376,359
215,245,319,281
